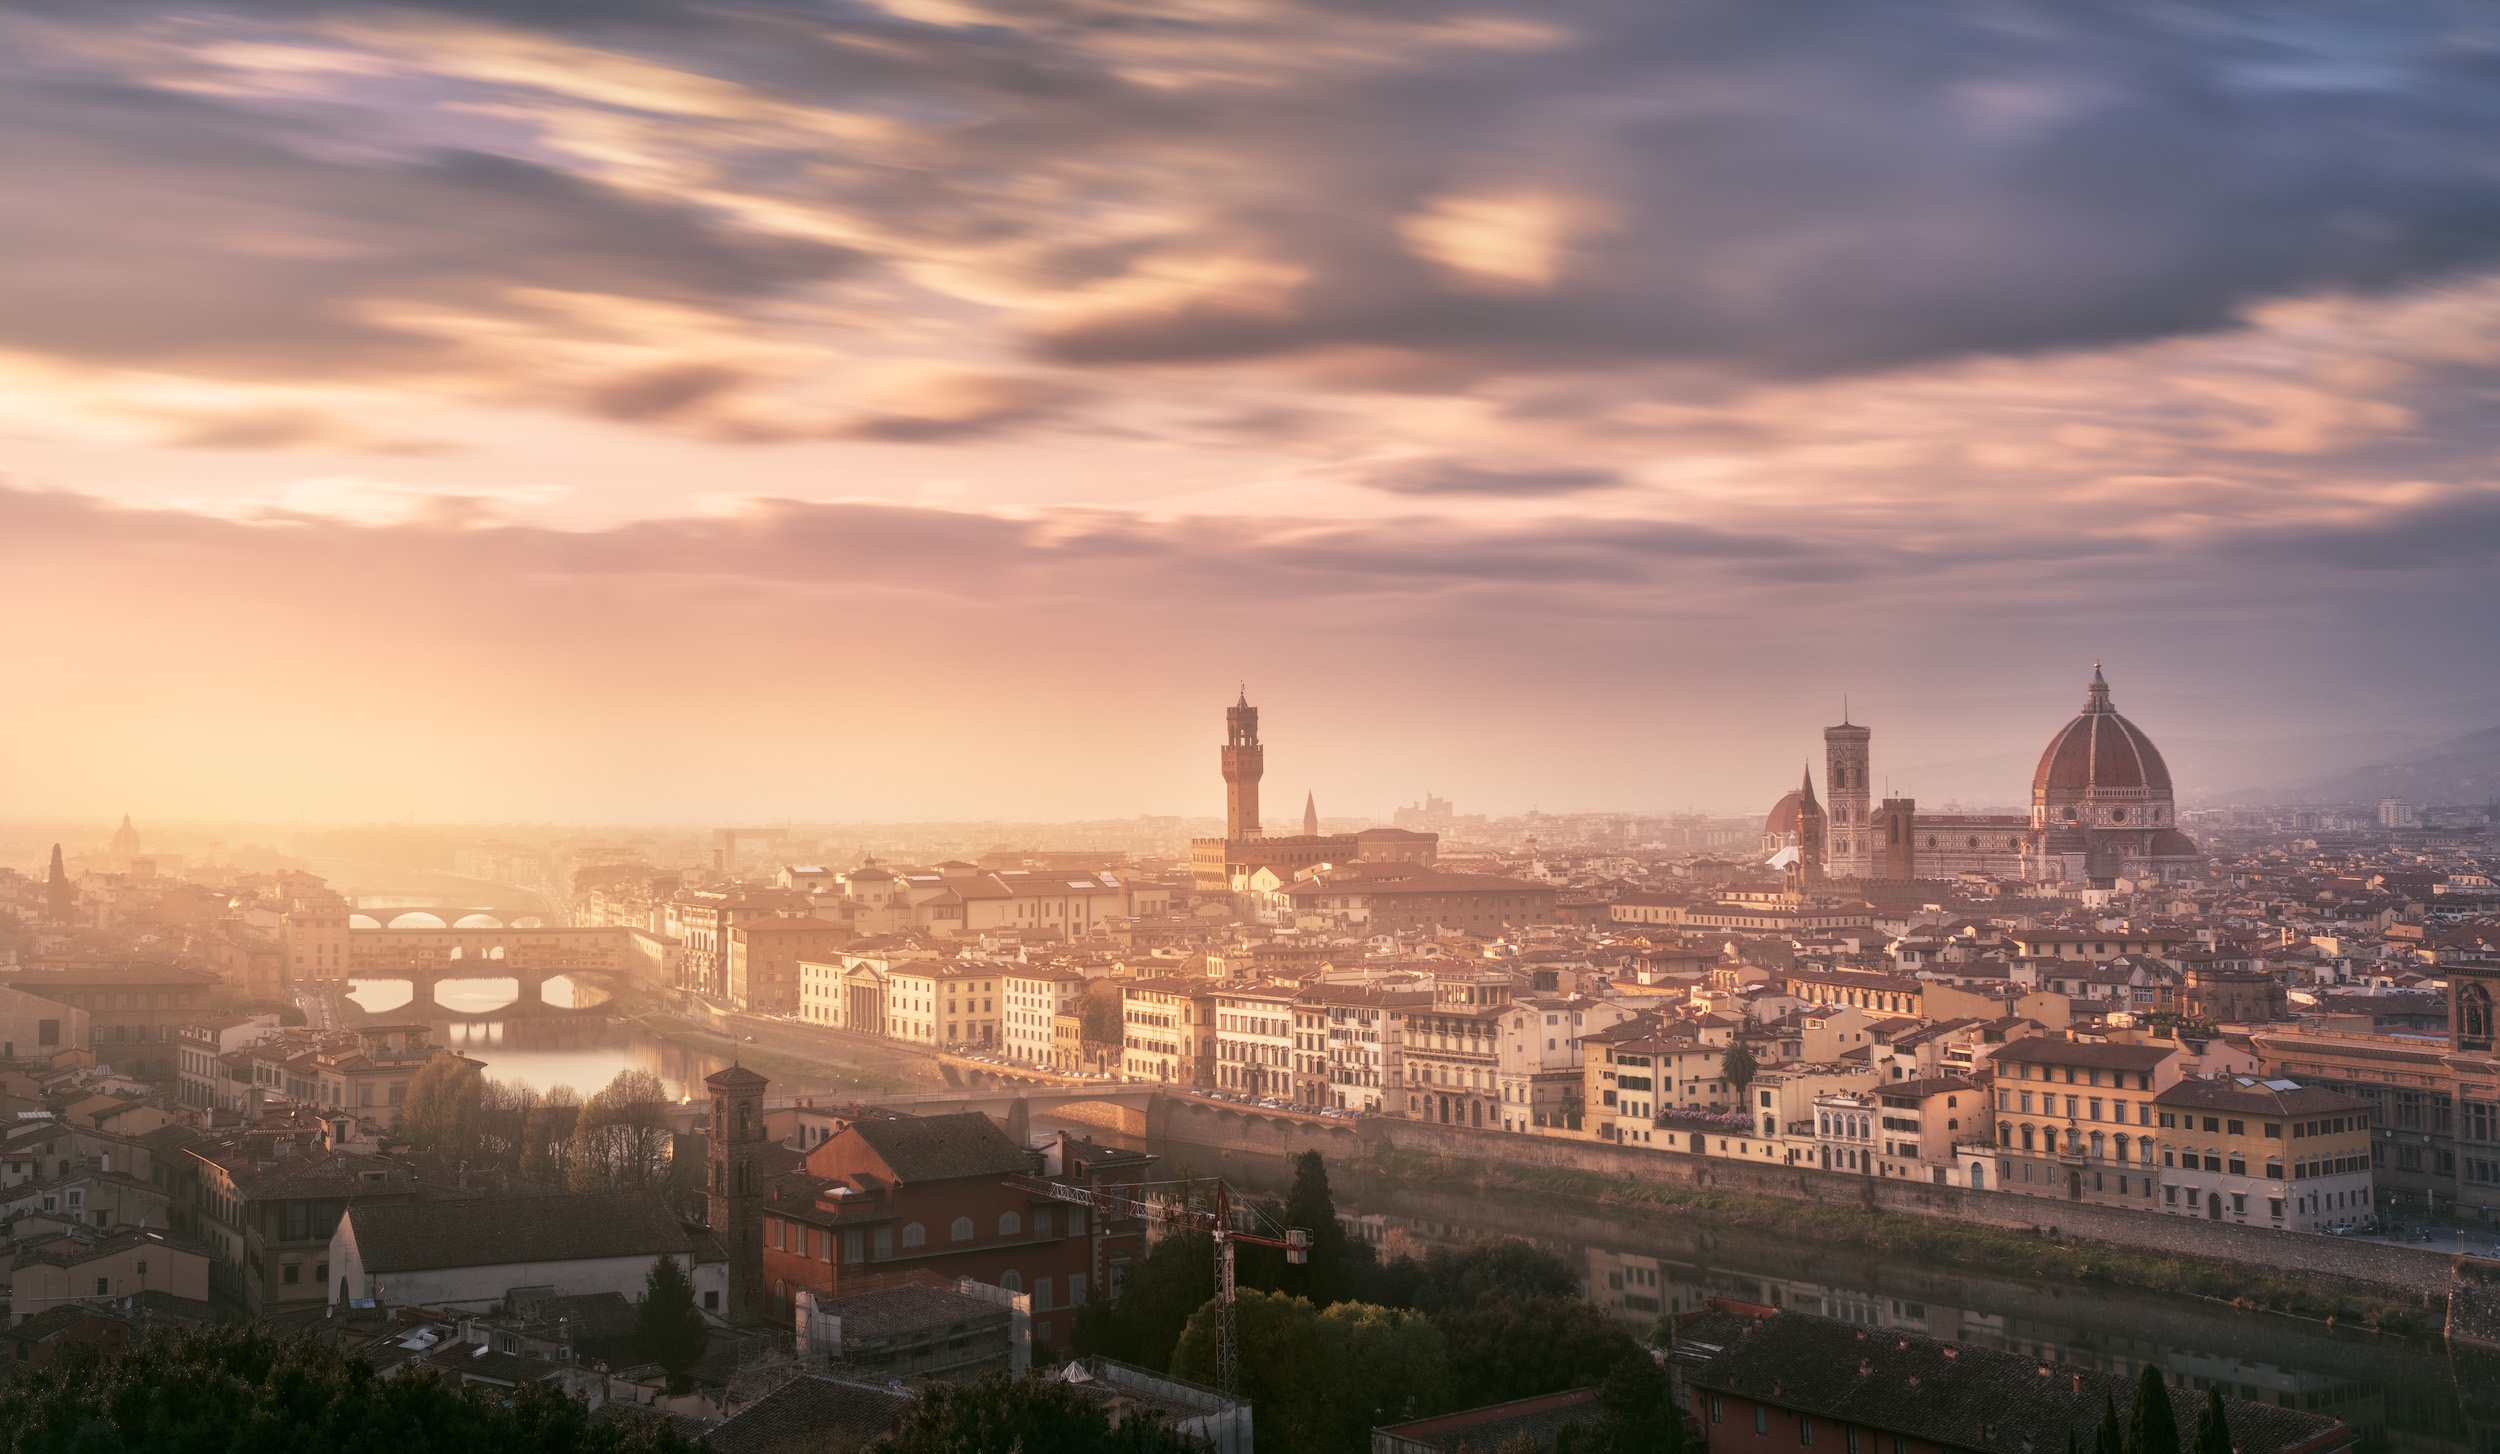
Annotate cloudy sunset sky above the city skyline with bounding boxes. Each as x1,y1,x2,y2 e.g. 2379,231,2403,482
0,0,2500,822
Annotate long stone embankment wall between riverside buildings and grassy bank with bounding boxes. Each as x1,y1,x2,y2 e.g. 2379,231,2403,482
1150,1099,2448,1299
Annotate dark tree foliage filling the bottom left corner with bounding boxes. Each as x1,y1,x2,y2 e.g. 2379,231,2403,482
0,1327,693,1454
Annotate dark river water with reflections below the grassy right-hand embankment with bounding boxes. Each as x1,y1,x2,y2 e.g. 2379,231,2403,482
1148,1144,2500,1454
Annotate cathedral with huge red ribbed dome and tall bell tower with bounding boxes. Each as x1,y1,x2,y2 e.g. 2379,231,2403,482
1763,662,2205,884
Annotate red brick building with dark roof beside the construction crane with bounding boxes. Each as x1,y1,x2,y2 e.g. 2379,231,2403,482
763,1112,1153,1342
